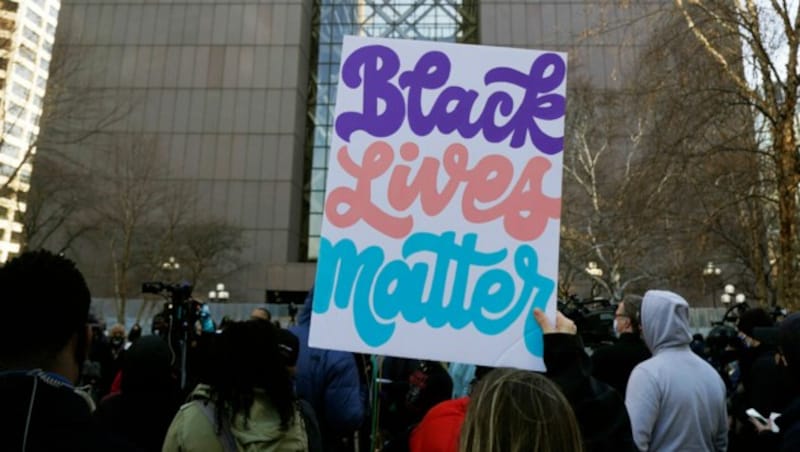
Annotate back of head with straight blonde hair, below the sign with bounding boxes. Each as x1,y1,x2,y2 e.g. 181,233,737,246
459,369,583,452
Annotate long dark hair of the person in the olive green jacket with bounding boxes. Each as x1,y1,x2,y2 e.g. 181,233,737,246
211,320,295,430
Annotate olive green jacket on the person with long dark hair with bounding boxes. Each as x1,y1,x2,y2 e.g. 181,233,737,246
162,385,308,452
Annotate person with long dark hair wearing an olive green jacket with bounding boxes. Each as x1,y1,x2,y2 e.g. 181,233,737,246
162,321,308,452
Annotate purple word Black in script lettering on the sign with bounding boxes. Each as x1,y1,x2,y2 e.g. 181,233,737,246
335,45,566,155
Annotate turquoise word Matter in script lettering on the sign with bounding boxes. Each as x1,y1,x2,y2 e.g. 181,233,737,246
313,231,555,356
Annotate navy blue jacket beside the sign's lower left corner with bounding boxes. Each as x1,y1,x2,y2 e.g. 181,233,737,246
290,288,366,451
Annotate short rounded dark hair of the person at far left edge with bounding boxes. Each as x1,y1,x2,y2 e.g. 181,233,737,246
0,250,91,368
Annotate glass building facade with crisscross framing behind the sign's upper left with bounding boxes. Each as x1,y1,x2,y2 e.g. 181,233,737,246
306,0,478,260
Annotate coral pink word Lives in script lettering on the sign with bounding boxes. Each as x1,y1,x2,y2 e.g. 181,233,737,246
325,141,561,241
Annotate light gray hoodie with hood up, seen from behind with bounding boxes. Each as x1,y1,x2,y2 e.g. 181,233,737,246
625,290,728,452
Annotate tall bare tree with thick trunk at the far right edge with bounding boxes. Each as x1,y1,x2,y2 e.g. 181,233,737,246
675,0,800,309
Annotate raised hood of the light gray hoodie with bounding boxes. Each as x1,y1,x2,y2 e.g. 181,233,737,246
641,290,692,354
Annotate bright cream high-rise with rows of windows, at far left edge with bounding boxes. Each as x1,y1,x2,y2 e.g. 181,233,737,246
0,0,61,262
